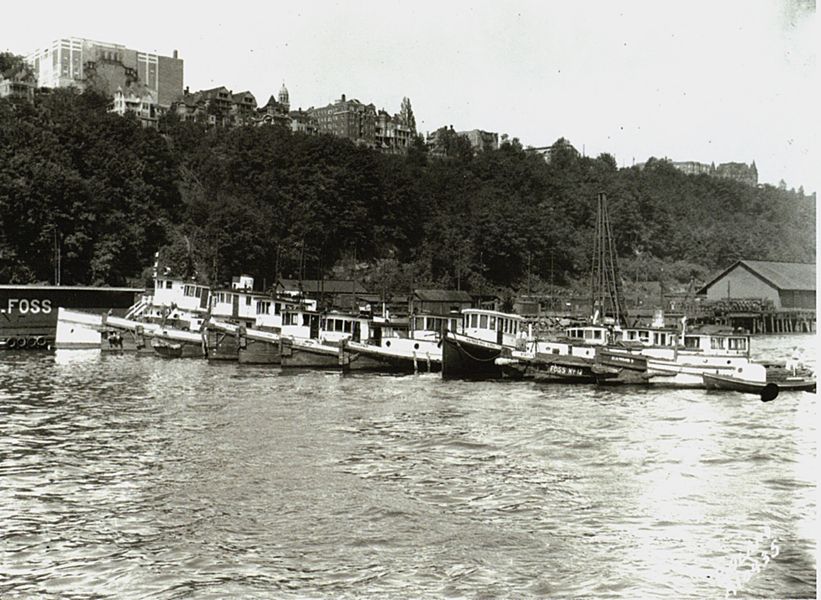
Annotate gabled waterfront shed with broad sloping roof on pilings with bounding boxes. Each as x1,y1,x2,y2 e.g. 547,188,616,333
698,260,816,310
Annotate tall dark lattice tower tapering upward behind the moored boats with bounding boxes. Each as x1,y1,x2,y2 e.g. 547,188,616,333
590,193,627,325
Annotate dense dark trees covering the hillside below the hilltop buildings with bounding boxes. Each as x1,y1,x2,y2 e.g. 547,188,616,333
0,90,815,291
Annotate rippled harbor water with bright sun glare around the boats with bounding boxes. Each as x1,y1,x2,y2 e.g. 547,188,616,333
0,336,817,599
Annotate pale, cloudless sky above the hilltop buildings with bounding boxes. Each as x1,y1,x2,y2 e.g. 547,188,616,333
0,0,821,193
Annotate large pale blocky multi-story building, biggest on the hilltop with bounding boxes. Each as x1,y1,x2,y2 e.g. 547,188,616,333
26,37,183,109
